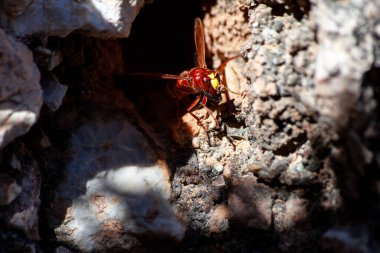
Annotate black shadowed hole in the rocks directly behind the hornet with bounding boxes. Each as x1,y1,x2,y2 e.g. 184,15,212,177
116,0,215,132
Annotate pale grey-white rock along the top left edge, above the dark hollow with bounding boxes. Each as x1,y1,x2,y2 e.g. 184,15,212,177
0,0,145,38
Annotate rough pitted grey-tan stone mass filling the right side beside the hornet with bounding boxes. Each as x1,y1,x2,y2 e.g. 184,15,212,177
167,1,379,252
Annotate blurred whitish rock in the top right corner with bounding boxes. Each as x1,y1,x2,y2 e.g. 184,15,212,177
314,0,380,129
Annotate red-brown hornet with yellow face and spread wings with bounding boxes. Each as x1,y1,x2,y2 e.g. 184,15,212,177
130,18,241,128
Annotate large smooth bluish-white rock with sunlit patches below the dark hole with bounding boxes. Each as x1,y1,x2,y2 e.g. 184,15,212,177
50,119,185,252
